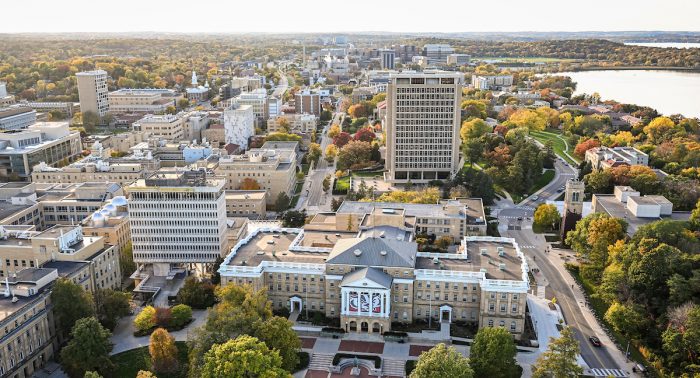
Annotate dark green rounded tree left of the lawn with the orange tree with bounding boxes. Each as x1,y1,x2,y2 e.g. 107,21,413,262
61,316,114,377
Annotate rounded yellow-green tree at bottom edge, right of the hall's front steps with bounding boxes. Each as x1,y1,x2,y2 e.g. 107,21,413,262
410,343,474,378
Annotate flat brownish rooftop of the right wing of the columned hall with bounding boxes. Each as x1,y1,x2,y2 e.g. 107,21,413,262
416,241,522,281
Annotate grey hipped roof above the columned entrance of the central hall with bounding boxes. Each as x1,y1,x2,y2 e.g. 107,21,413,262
326,236,418,268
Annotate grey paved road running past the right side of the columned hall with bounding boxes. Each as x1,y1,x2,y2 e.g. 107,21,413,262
497,159,618,369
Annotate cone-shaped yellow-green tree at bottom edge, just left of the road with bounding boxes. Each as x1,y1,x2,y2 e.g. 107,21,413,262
532,327,583,378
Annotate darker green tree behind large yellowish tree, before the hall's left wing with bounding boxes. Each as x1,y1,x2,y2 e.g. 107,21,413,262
254,316,301,371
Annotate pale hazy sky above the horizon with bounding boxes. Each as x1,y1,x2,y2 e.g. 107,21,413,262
0,0,700,33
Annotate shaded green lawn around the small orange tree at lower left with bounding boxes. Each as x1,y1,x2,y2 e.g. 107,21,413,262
111,341,187,378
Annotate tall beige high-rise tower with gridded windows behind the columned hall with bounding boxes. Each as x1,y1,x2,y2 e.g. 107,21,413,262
386,72,463,183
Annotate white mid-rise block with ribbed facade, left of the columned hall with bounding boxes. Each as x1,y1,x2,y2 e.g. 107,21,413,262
128,170,226,276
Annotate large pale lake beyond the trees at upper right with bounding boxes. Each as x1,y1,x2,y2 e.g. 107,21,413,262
557,70,700,117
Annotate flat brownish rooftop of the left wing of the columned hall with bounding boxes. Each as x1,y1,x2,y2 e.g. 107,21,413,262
229,232,328,266
